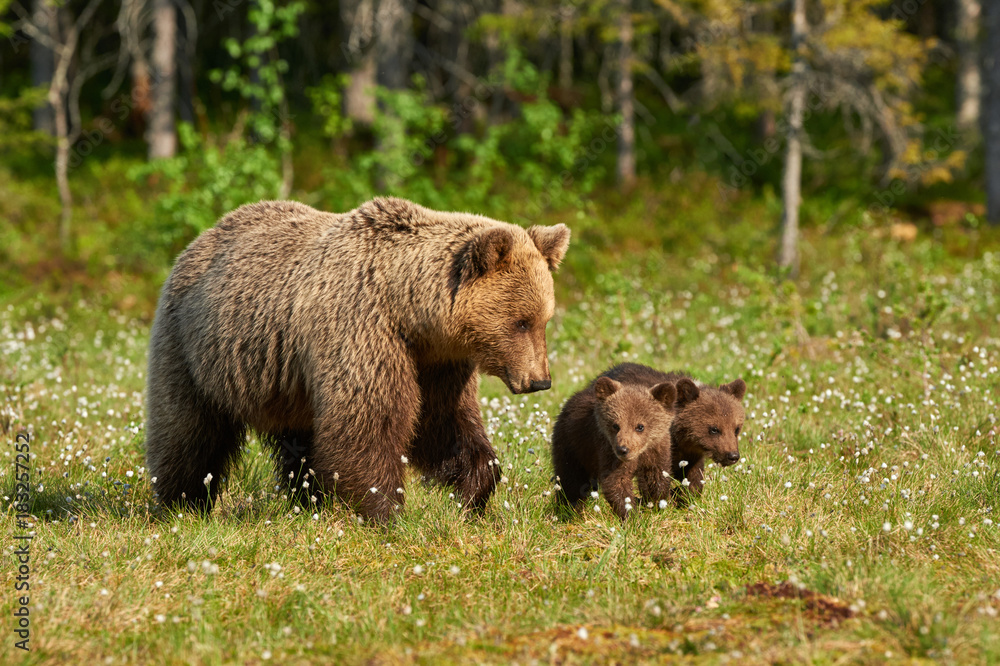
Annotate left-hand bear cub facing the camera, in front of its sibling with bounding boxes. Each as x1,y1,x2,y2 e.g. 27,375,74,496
552,368,677,520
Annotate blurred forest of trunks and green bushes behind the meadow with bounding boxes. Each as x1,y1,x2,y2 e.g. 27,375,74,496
0,0,1000,295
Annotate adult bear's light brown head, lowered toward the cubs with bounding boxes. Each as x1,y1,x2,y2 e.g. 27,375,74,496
453,224,569,393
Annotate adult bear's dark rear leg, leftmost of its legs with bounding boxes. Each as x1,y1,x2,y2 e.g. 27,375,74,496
146,336,246,510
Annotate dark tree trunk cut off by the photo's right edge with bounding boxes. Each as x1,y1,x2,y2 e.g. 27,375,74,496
982,0,1000,224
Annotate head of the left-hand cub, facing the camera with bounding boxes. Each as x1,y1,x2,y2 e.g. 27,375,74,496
594,377,677,460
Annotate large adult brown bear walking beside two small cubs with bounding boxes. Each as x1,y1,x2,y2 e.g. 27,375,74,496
146,198,569,519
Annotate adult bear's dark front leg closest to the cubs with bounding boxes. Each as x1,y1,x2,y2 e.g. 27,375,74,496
411,362,500,511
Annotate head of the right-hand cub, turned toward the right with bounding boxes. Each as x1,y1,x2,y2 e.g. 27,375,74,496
674,377,747,467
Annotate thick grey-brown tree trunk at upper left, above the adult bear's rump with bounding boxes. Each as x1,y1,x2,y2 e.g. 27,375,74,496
148,0,177,160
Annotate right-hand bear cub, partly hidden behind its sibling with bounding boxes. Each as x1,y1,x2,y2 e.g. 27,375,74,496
608,363,747,502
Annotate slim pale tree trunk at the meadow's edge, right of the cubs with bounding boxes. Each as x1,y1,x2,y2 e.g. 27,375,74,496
778,0,808,278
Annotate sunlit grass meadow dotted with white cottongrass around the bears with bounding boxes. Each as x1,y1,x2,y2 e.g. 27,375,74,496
0,220,1000,664
